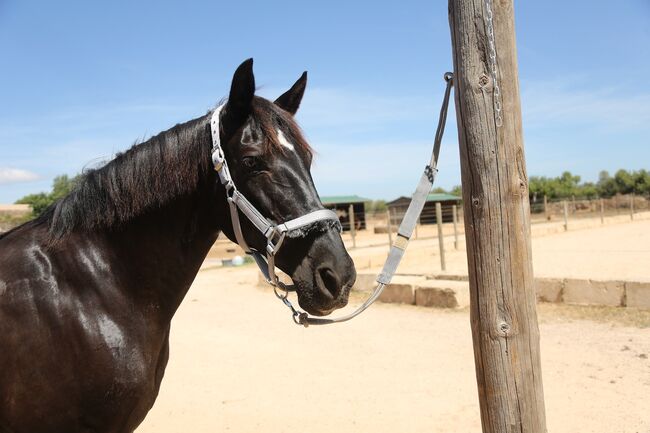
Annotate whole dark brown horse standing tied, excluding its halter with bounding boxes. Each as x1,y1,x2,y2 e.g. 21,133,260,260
0,59,356,433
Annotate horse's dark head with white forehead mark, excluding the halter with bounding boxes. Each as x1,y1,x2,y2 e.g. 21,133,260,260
216,59,356,315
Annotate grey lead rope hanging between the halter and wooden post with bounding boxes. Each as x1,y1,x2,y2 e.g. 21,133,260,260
274,72,454,327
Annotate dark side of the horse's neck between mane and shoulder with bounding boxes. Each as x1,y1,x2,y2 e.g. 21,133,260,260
108,184,226,320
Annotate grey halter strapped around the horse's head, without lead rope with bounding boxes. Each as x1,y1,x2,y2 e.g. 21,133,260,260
210,104,342,296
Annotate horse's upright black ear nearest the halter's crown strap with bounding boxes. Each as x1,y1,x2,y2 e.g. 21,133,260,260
223,59,255,131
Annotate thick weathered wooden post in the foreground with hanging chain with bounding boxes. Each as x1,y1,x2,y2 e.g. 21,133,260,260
449,0,546,433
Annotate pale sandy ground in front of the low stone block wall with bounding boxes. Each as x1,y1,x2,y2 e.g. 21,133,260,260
137,260,650,433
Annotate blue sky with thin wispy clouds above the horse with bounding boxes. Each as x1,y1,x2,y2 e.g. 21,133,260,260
0,0,650,203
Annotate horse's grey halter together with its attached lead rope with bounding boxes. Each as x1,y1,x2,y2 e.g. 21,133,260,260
211,72,454,327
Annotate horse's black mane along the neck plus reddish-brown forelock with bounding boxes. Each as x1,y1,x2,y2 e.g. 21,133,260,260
33,97,312,241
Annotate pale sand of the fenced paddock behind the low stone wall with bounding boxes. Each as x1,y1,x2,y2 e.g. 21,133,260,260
208,212,650,282
